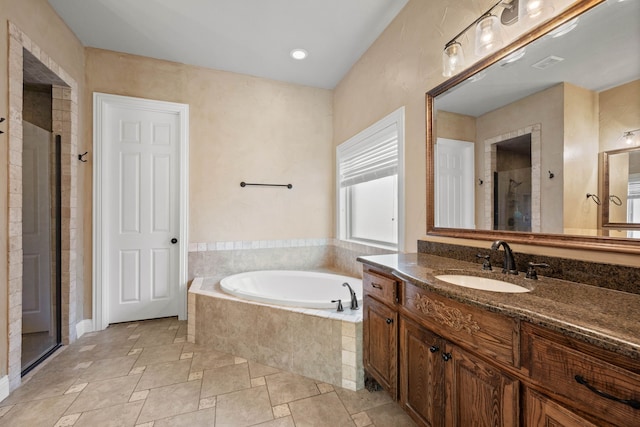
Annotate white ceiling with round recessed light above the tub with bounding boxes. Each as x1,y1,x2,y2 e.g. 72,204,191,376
49,0,408,89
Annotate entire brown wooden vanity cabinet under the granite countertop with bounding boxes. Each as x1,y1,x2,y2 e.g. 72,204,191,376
363,266,640,427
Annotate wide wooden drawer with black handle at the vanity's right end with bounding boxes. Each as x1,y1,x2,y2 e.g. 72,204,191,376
522,324,640,427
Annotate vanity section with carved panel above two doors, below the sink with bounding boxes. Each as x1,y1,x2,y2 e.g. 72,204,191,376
399,283,520,427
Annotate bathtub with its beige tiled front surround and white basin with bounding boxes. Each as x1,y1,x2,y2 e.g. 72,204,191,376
187,271,364,390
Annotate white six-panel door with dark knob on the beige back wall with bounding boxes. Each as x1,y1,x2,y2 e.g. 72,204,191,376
97,97,186,325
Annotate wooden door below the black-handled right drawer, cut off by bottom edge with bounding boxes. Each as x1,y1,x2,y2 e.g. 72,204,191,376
524,389,596,427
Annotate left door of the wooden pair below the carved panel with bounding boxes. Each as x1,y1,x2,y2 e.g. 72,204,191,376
400,318,444,427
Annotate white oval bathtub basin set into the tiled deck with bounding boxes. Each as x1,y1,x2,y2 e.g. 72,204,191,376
220,270,362,311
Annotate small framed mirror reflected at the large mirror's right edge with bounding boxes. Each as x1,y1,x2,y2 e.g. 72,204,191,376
603,147,640,238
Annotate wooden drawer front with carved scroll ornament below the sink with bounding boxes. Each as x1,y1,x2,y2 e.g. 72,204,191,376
403,283,520,367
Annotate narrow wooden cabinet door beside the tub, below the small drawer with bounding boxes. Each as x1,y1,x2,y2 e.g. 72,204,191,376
363,296,398,400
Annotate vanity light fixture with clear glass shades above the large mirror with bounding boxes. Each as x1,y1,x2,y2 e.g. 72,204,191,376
442,0,545,77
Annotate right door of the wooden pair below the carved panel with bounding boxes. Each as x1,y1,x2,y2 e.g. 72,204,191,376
441,344,519,427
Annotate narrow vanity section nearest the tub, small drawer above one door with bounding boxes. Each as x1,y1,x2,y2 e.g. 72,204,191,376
362,269,399,400
